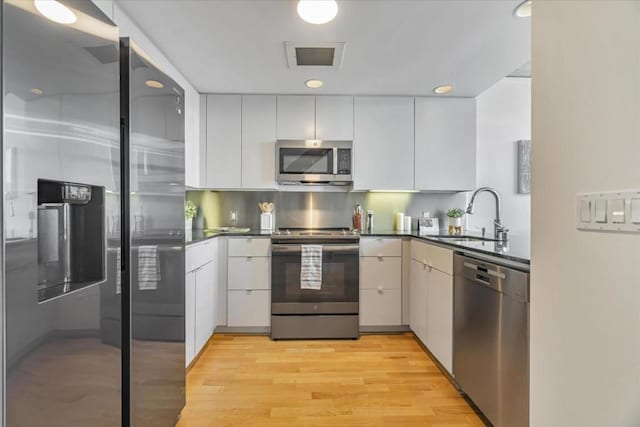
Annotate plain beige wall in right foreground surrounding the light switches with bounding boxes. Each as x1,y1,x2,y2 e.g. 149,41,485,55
531,0,640,427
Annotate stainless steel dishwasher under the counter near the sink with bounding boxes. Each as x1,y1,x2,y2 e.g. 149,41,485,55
453,254,529,427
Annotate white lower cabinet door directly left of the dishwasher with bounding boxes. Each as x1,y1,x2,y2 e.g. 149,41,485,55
427,269,453,373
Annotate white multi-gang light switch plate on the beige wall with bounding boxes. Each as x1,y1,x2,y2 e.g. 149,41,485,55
576,190,640,233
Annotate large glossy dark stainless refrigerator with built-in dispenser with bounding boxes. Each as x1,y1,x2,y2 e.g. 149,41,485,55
1,0,184,427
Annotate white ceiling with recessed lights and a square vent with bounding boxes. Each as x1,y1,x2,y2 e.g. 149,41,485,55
119,0,531,96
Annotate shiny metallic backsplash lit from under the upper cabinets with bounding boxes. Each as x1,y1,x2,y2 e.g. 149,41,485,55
187,190,467,230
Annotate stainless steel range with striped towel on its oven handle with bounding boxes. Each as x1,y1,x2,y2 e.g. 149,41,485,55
271,229,360,339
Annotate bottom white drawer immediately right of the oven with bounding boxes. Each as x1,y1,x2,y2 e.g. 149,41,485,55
360,289,402,326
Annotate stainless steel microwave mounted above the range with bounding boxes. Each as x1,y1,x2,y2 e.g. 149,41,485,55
276,140,353,185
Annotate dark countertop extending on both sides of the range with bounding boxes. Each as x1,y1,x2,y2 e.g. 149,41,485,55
186,230,531,265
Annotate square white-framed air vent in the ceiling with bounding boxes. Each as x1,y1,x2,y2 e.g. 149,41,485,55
284,42,345,69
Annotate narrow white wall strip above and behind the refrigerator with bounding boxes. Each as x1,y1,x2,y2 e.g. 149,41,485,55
93,0,204,186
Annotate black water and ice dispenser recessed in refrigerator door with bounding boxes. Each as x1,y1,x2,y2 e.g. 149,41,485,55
37,179,106,302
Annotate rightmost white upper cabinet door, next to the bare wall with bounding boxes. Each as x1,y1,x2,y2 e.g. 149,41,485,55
415,98,476,191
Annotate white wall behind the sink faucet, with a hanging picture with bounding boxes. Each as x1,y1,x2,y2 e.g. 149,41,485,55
468,78,531,240
